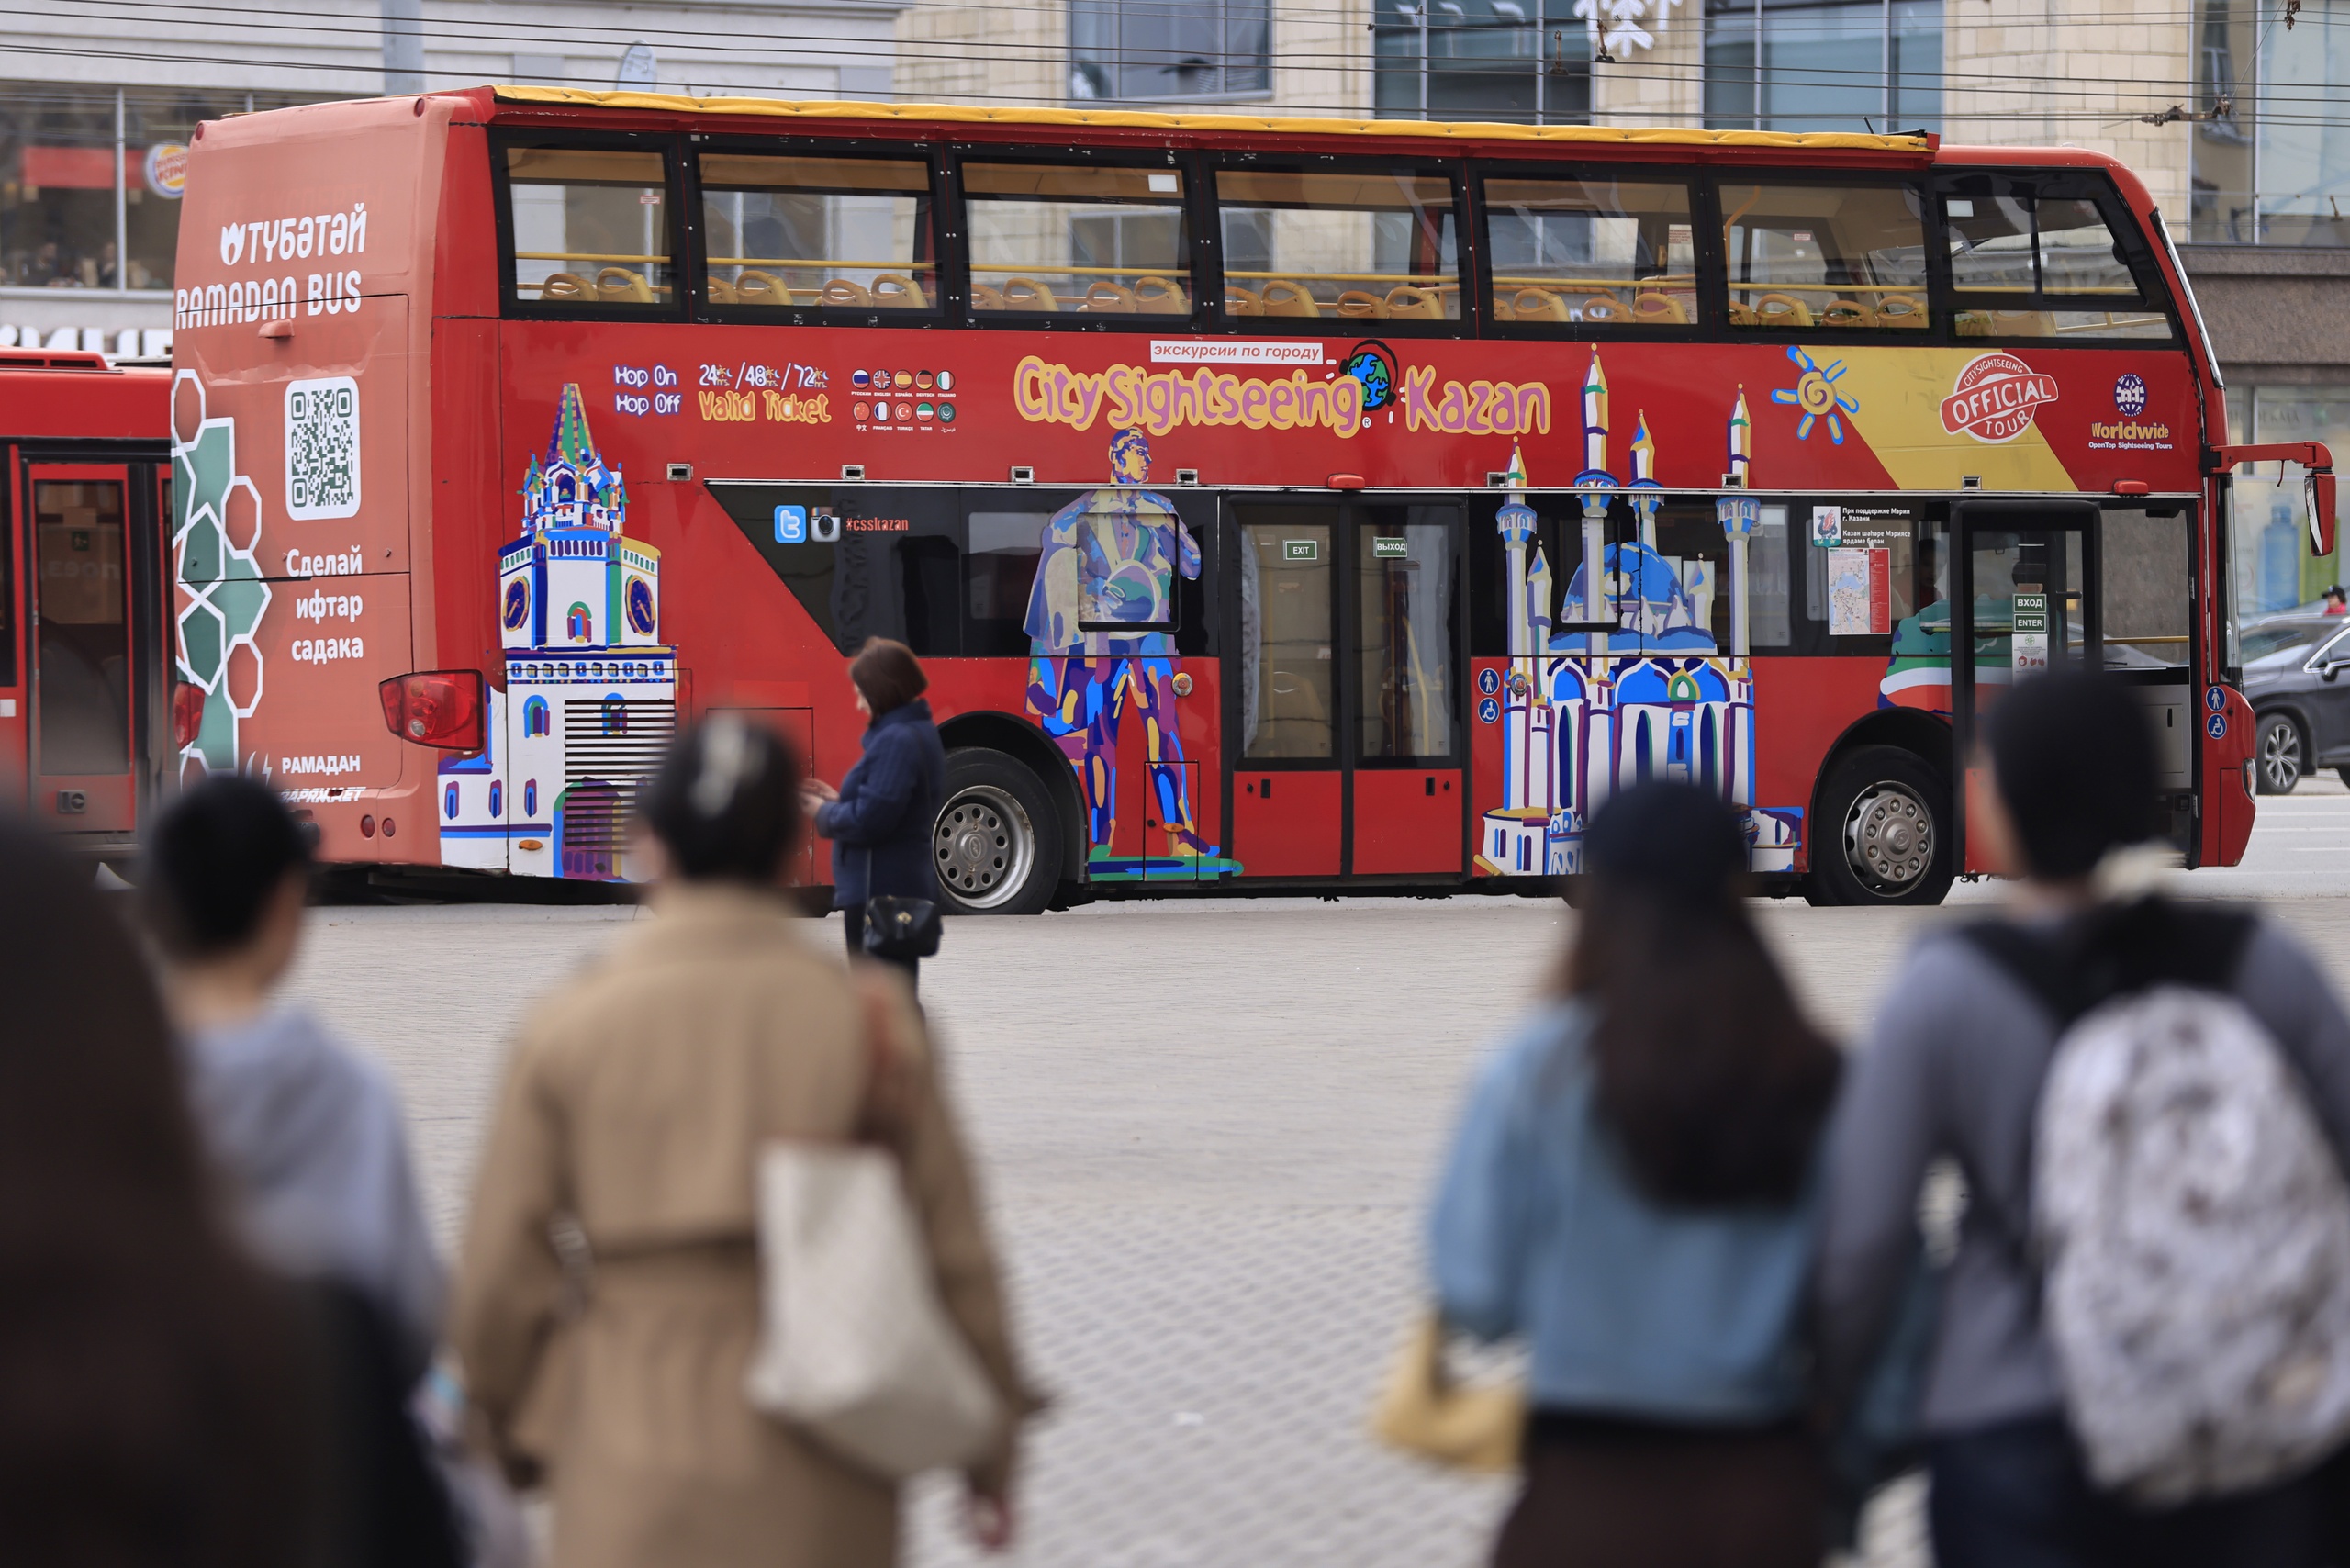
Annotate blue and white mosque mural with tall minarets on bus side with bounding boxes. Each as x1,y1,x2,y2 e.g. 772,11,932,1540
1476,348,1803,877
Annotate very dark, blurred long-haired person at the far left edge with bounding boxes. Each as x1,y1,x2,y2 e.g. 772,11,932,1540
0,808,324,1568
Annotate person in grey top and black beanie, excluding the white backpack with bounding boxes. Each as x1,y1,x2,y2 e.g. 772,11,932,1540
1818,672,2350,1568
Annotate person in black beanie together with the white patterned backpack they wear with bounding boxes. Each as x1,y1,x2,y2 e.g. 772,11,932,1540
1818,672,2350,1568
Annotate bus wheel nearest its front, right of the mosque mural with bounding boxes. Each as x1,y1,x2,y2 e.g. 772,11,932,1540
1805,745,1953,905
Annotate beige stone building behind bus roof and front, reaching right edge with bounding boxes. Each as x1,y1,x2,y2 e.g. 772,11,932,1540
895,0,2350,616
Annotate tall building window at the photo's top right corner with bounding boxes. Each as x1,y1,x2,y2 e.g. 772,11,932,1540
2188,0,2350,244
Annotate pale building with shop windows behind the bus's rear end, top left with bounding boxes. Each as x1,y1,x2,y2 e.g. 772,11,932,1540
0,0,898,355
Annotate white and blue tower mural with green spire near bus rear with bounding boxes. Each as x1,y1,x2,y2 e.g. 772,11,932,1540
437,386,677,881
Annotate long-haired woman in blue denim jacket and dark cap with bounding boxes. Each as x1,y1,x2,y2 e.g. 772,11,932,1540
1428,783,1840,1568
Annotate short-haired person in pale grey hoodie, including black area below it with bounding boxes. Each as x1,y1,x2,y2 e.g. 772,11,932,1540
139,773,484,1568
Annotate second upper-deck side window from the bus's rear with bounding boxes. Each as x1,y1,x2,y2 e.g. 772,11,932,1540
700,152,937,310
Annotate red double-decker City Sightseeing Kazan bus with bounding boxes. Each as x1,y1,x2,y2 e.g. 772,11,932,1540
172,87,2332,913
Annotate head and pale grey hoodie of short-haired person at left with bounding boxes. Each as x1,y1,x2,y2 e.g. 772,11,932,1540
139,776,446,1383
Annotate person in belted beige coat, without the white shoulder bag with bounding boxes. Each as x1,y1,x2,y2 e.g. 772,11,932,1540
452,714,1034,1568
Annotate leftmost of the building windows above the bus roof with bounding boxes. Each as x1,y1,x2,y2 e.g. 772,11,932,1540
1069,0,1274,101
